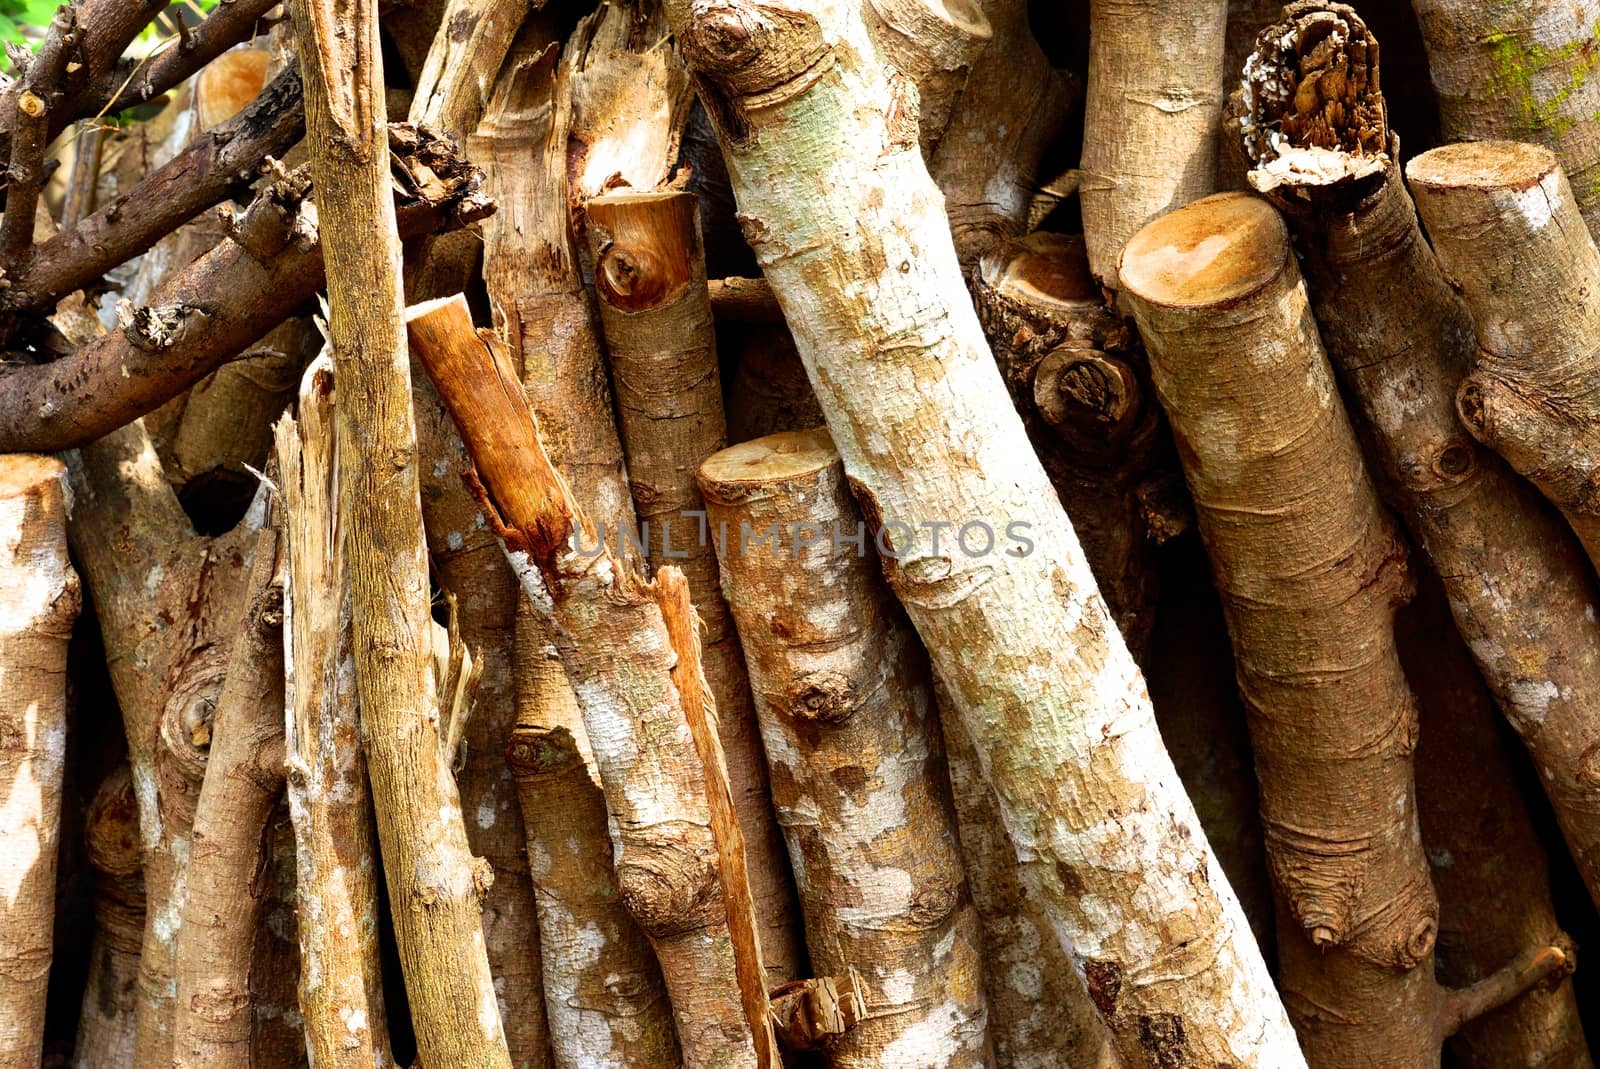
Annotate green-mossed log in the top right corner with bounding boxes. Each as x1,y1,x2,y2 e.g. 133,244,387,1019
1411,0,1600,234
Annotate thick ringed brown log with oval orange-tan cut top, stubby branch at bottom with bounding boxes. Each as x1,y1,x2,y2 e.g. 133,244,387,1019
1120,194,1566,1069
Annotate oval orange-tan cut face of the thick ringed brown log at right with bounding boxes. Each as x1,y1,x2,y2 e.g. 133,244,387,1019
1118,194,1291,309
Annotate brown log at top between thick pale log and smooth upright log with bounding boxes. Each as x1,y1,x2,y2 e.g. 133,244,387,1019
928,0,1078,269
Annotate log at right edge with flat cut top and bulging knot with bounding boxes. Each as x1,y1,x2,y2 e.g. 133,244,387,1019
1406,141,1600,585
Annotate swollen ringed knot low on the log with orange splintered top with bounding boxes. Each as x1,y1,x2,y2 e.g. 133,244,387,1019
616,824,722,939
